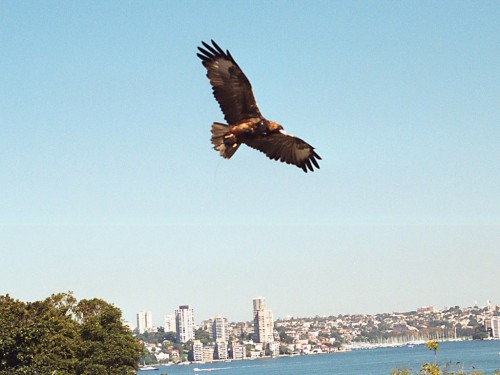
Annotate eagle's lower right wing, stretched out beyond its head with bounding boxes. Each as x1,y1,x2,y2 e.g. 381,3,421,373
244,131,321,172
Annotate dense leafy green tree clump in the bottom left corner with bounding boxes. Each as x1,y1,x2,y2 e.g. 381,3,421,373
0,293,142,375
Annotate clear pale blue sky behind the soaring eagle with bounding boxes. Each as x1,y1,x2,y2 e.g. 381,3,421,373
0,1,500,324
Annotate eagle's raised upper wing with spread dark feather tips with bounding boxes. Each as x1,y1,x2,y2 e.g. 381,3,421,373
197,40,262,125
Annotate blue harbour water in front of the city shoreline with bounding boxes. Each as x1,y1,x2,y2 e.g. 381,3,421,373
138,340,500,375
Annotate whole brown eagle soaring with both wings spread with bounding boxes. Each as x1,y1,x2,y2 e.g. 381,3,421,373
197,40,321,172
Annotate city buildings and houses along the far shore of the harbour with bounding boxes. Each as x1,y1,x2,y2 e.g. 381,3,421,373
134,297,500,363
